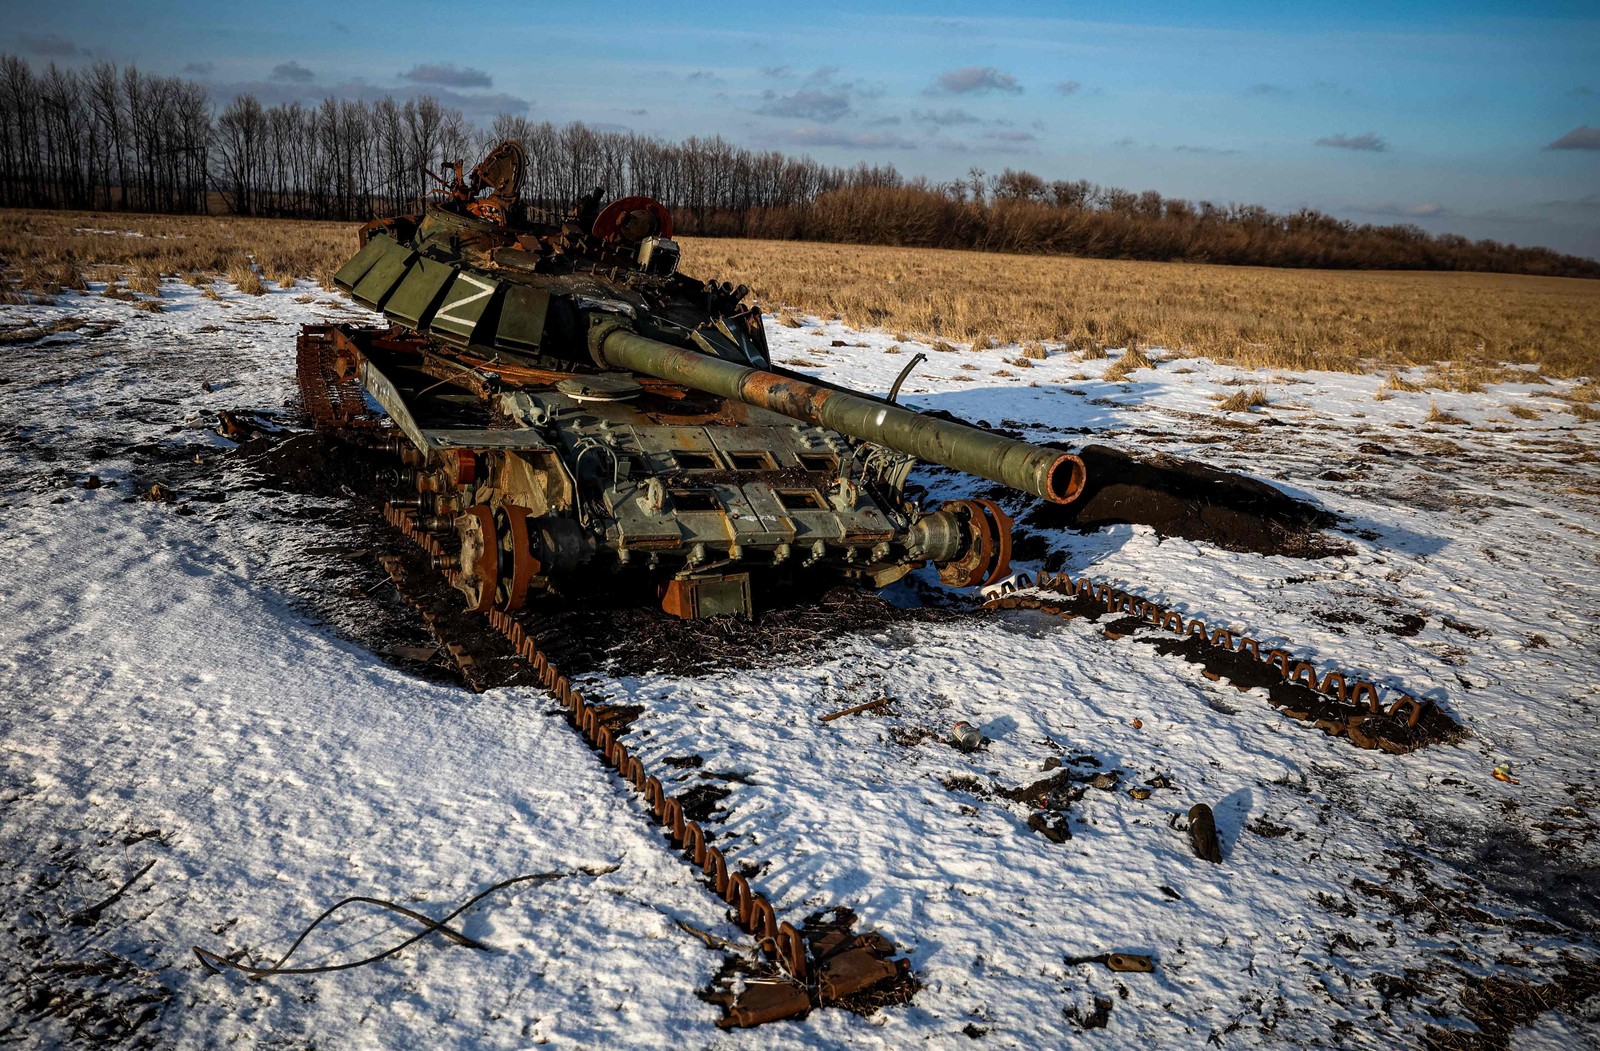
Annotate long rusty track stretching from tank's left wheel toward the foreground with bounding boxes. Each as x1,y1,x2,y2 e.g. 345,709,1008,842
368,504,909,1027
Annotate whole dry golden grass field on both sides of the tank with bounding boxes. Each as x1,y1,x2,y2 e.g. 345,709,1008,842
0,210,1600,380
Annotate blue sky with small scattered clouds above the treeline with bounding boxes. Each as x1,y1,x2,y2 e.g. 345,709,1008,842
9,0,1600,256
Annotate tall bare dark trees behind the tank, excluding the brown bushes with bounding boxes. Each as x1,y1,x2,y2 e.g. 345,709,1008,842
0,56,901,234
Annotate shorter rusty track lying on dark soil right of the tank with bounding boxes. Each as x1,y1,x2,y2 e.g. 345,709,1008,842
984,573,1461,755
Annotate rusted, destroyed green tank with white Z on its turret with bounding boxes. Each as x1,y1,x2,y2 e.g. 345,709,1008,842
299,142,1085,617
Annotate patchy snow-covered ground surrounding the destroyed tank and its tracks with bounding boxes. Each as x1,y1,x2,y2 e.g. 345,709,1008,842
0,282,1600,1048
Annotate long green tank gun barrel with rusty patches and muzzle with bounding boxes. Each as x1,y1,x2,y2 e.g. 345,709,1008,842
589,317,1085,504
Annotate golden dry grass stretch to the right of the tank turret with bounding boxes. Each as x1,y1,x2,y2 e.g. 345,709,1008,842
683,238,1600,378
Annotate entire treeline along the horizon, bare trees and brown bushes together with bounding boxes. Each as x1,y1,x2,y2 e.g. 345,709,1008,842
0,56,1600,277
